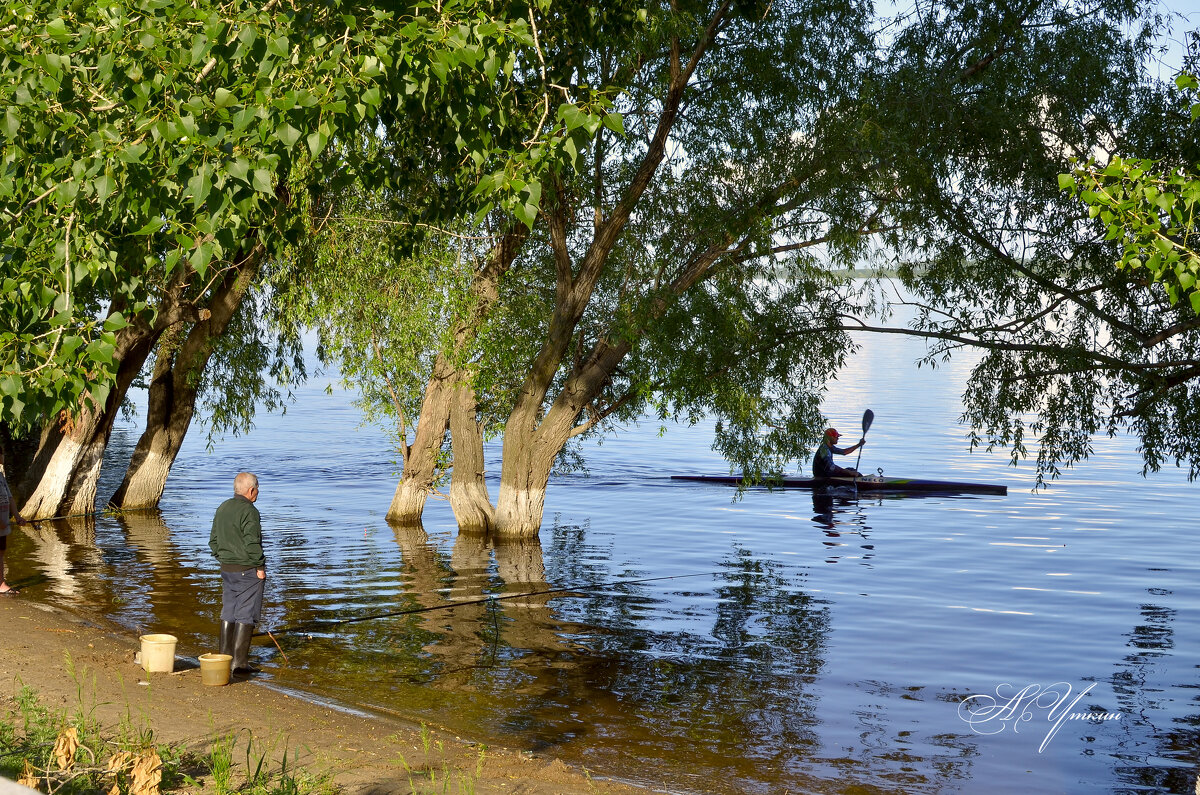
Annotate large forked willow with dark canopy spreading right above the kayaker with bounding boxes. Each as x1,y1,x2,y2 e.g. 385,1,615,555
302,0,1161,536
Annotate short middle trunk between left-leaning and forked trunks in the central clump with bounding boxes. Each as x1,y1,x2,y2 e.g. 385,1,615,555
450,371,496,533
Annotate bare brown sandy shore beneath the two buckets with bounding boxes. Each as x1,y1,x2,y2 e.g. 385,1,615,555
0,597,665,795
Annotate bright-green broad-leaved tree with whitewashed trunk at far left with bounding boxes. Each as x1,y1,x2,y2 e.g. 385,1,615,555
0,0,571,516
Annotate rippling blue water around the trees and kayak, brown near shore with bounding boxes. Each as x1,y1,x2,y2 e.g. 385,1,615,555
8,314,1200,794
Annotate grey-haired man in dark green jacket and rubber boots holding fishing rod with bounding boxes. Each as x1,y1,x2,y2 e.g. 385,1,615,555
209,472,266,673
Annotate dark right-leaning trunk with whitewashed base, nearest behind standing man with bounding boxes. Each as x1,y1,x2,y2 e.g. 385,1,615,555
109,249,262,509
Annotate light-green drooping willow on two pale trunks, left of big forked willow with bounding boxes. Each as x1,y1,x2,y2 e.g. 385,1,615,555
280,2,638,526
